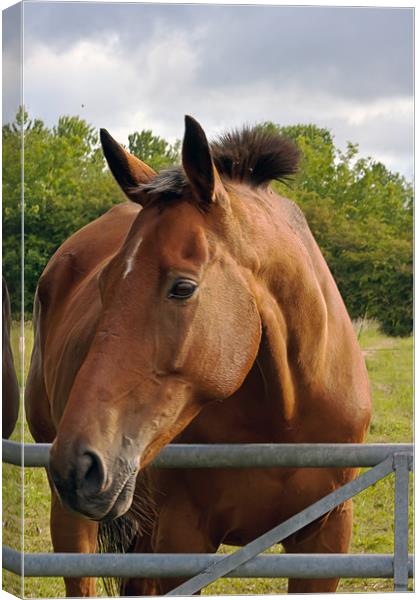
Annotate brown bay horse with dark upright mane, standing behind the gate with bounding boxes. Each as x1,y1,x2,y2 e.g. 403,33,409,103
26,116,371,596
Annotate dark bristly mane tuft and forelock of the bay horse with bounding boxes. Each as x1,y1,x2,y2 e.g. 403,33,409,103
139,126,299,200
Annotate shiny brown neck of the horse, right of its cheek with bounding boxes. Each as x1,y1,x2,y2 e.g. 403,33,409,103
227,189,369,427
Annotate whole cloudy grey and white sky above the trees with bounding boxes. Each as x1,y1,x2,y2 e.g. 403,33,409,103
3,2,414,179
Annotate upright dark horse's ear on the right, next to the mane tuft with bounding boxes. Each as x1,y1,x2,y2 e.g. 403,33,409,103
182,115,227,205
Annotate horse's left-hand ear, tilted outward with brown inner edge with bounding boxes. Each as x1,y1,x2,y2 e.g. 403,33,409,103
100,129,156,204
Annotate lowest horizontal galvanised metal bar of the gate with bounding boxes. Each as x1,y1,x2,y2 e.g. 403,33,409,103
3,546,413,579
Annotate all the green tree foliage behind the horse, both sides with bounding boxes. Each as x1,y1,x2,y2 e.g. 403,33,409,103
3,109,413,335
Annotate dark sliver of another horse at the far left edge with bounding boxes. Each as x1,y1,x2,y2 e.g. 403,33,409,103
2,277,20,438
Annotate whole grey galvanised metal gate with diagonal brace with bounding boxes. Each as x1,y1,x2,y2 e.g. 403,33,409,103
3,440,413,595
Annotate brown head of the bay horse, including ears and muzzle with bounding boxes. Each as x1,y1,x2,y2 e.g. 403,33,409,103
51,117,272,519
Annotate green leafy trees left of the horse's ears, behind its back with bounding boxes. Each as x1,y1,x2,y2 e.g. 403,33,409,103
3,111,123,318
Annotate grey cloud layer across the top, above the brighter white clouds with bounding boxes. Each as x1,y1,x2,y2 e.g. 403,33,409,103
25,3,413,98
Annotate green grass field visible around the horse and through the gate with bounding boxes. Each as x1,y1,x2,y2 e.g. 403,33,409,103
3,324,413,598
